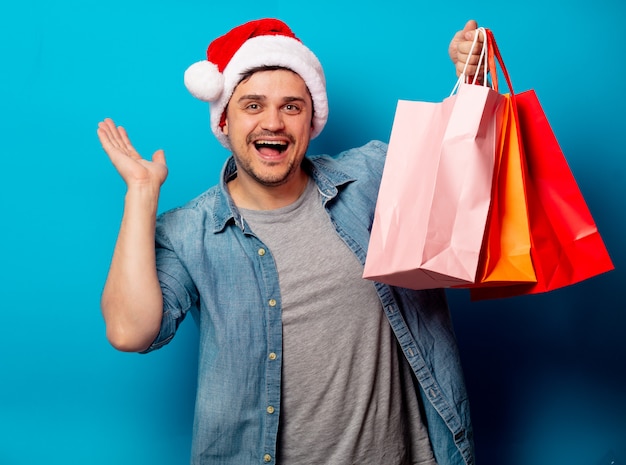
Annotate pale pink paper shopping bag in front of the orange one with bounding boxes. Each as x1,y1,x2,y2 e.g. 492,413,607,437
363,29,504,289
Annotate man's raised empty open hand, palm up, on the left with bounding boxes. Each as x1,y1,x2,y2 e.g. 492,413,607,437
98,118,167,191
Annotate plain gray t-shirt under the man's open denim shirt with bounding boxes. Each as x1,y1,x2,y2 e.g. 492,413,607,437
241,181,436,465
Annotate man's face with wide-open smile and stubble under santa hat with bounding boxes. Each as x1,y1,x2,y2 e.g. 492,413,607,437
223,70,313,187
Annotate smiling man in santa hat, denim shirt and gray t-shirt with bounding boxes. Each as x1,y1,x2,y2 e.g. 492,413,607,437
98,19,486,465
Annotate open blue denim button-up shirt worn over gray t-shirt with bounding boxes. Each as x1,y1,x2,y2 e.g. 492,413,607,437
148,141,474,465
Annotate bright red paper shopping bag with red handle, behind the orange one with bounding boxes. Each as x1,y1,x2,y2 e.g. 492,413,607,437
471,31,614,300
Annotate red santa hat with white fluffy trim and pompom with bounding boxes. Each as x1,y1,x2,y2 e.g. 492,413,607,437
185,19,328,149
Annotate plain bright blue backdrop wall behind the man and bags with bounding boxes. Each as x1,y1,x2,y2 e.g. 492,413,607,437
0,0,626,465
